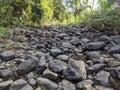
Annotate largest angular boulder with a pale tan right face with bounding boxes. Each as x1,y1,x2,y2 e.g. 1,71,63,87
62,60,86,80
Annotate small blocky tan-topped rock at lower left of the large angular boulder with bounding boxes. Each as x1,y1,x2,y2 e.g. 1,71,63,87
43,69,58,81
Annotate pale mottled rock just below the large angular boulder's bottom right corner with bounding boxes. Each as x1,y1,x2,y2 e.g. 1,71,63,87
76,79,94,89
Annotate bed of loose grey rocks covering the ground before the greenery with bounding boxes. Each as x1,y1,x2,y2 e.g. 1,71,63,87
0,25,120,90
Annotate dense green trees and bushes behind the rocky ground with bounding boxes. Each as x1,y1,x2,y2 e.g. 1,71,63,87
0,0,120,29
